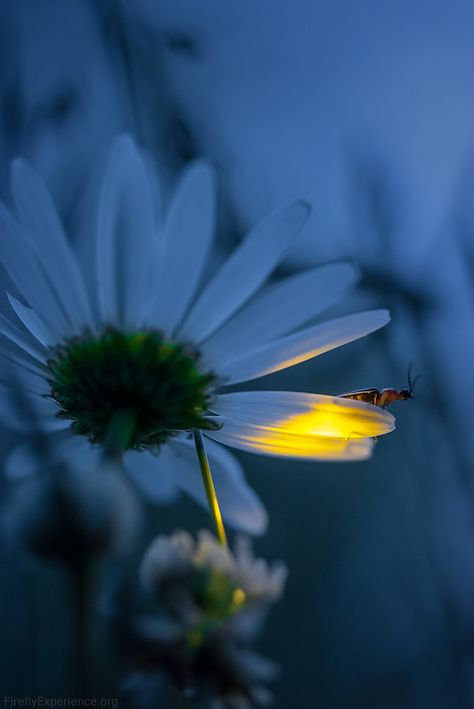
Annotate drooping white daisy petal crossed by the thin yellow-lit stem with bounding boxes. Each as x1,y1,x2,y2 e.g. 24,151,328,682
164,438,268,535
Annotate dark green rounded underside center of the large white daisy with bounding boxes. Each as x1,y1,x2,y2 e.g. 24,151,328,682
48,329,214,450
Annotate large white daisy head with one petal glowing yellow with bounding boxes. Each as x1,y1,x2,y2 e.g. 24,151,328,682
0,137,394,533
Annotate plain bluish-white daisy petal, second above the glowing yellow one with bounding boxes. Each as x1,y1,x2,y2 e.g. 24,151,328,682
201,263,357,362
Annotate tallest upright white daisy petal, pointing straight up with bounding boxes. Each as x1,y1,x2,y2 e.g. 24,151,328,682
97,136,158,330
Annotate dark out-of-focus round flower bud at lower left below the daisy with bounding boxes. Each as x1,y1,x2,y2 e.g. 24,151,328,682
1,372,139,570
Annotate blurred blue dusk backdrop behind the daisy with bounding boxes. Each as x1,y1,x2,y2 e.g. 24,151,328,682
0,0,474,709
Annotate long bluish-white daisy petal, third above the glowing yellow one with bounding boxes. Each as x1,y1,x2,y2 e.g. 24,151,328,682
179,202,310,342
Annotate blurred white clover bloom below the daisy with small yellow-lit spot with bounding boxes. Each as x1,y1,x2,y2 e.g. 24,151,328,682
128,531,286,708
